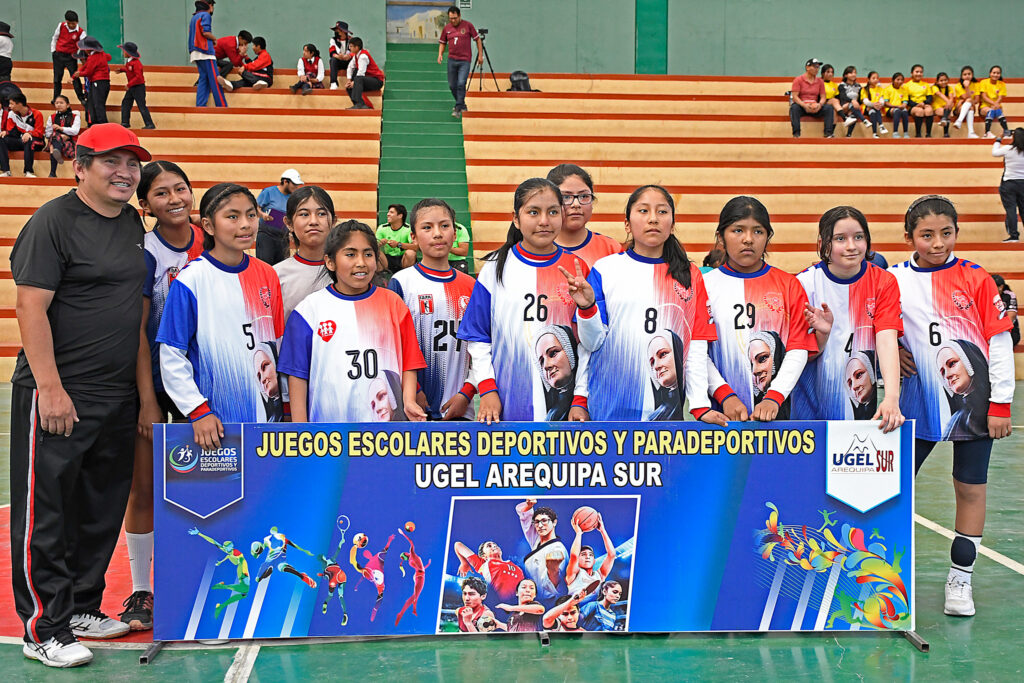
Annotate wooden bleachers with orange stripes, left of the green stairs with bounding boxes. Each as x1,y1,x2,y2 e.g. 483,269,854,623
0,61,381,377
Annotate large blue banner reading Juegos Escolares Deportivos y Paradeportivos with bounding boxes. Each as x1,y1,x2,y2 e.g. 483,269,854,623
154,422,914,640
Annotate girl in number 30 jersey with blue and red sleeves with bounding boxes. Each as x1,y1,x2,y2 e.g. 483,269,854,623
281,220,426,422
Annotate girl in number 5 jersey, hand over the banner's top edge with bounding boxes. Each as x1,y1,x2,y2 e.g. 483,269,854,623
157,182,285,451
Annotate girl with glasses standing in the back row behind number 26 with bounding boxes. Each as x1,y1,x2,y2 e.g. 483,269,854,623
548,164,623,266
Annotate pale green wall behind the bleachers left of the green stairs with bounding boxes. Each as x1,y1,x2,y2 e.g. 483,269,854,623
0,0,386,70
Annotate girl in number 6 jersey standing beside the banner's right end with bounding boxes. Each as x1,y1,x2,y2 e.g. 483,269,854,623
890,195,1014,616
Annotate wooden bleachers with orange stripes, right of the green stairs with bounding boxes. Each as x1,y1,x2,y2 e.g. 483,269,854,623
463,74,1024,379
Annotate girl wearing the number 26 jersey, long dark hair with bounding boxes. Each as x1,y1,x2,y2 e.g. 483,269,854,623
459,178,590,424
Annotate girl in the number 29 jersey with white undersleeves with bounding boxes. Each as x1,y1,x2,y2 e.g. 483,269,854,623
703,197,817,421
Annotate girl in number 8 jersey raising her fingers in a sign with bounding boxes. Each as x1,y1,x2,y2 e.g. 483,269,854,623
560,185,726,426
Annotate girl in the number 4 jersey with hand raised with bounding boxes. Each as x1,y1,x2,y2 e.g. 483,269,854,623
793,206,903,432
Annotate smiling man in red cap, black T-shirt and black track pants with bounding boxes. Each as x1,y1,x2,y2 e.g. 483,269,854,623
10,123,151,668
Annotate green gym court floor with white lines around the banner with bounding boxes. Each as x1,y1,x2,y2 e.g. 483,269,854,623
0,382,1024,683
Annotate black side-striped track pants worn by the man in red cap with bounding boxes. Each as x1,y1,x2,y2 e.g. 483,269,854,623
10,384,137,643
